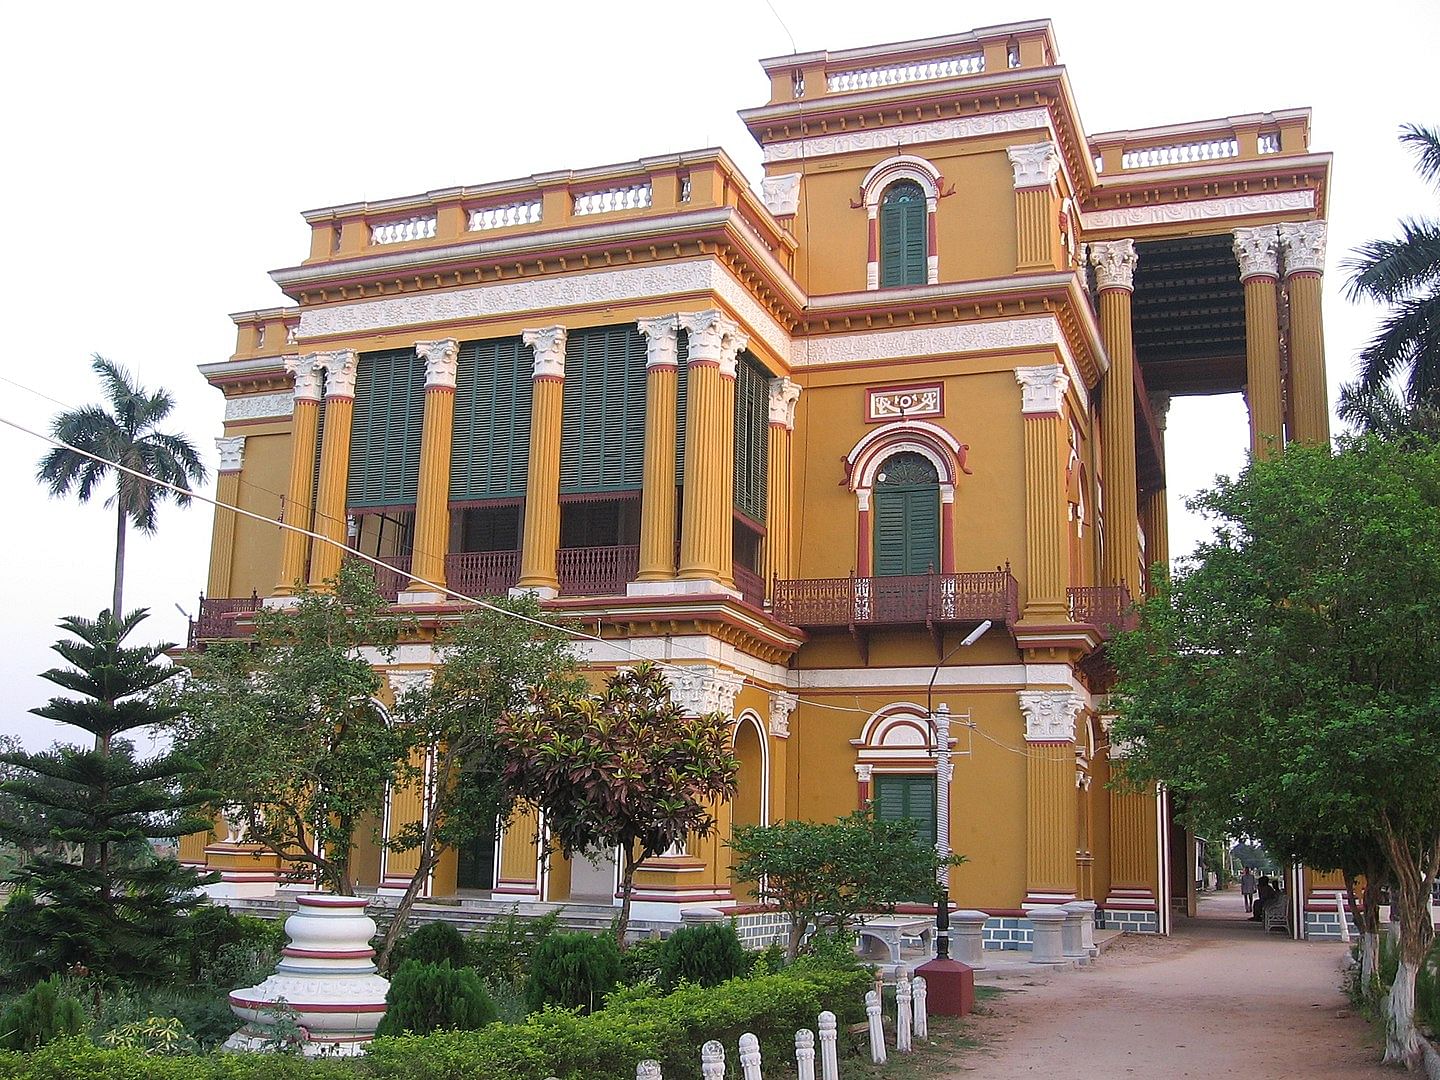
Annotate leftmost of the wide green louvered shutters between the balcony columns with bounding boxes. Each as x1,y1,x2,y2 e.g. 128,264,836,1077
346,348,425,507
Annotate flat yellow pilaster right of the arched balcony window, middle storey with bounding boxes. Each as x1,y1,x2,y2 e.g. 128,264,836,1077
1015,364,1070,625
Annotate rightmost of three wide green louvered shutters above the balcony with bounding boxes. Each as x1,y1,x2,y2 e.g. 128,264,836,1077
560,324,645,495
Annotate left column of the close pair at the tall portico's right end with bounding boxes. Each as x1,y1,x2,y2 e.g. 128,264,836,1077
1236,225,1284,458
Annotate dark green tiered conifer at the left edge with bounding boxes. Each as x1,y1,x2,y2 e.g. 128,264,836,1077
0,611,209,981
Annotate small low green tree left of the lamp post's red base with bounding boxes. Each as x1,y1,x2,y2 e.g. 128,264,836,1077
730,806,965,959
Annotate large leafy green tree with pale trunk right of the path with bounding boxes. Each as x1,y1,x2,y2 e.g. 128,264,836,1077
1110,439,1440,1077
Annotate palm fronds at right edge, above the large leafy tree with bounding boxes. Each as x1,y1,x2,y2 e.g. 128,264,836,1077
1344,124,1440,406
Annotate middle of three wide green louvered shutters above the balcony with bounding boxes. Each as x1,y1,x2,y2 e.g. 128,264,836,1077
449,337,533,503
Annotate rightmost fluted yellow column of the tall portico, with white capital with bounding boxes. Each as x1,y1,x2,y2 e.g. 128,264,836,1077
1280,222,1331,445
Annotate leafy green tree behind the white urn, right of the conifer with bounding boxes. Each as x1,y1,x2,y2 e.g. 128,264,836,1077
176,562,408,896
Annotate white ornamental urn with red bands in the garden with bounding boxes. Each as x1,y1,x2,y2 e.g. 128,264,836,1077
225,893,390,1057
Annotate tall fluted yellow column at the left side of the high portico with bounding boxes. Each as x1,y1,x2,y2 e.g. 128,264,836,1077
1090,240,1140,585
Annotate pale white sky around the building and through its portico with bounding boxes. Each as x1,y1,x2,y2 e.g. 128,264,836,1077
0,0,1440,749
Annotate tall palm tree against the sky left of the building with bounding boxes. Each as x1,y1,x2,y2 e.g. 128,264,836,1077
36,354,206,619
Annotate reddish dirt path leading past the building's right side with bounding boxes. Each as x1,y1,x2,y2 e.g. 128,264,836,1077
949,893,1397,1080
